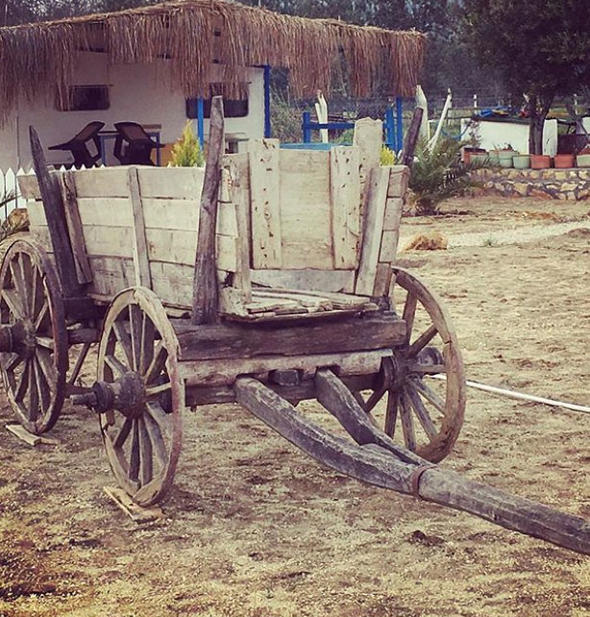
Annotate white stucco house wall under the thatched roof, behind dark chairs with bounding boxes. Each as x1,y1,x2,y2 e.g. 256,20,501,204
0,52,264,169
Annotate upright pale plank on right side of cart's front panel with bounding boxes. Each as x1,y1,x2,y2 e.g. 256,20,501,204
330,147,361,270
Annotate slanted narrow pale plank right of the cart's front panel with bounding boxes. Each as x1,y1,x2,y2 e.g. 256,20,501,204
355,167,389,296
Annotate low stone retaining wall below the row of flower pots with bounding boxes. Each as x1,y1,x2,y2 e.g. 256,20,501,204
475,167,590,200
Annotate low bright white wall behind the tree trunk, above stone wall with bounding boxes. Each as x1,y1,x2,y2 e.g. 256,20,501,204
461,119,557,156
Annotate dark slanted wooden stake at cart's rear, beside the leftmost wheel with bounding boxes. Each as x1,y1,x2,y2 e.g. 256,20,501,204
29,126,82,298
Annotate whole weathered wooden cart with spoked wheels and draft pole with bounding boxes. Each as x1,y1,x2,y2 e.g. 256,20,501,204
0,99,590,553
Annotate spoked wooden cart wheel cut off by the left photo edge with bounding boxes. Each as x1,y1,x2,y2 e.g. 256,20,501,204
0,240,68,435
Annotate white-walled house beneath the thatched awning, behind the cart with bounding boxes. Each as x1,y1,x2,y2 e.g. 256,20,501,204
0,51,265,169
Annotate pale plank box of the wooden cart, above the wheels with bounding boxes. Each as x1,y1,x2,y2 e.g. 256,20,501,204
19,119,408,321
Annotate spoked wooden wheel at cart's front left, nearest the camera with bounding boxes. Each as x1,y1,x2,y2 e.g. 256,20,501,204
95,287,184,506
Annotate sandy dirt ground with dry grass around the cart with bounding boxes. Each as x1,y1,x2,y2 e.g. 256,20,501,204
0,199,590,617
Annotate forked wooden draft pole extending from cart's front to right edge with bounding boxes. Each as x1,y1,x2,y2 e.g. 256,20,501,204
234,369,590,555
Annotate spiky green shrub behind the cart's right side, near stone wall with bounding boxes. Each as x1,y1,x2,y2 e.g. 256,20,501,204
410,139,489,214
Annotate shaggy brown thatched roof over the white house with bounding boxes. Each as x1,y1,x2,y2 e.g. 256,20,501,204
0,0,425,117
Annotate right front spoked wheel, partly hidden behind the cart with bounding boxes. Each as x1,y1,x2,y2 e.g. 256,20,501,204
364,268,465,462
